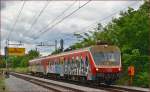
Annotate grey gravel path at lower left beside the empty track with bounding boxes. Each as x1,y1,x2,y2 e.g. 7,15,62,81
5,76,53,92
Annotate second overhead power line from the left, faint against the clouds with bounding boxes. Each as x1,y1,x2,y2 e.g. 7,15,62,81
23,1,50,34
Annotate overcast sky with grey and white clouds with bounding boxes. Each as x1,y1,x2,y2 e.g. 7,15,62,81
1,0,143,55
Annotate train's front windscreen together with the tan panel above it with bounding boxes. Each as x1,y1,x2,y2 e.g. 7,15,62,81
90,45,121,66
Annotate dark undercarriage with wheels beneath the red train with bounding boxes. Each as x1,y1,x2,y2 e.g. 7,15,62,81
31,72,120,85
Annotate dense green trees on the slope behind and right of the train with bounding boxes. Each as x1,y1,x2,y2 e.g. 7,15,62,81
68,1,150,87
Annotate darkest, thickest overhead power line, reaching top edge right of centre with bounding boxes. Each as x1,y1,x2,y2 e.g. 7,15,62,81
35,0,91,40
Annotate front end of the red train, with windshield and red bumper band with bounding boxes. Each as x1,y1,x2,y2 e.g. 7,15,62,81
91,44,121,84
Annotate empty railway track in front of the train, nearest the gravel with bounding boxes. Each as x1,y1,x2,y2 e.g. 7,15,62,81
10,73,107,92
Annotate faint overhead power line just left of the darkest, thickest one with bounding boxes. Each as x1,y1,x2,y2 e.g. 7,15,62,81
32,1,76,36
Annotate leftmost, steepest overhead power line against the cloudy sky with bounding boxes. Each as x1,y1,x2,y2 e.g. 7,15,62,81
7,1,25,40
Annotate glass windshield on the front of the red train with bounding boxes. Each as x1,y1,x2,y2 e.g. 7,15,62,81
92,52,120,65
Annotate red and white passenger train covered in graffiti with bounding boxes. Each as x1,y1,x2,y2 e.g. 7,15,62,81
29,44,121,84
